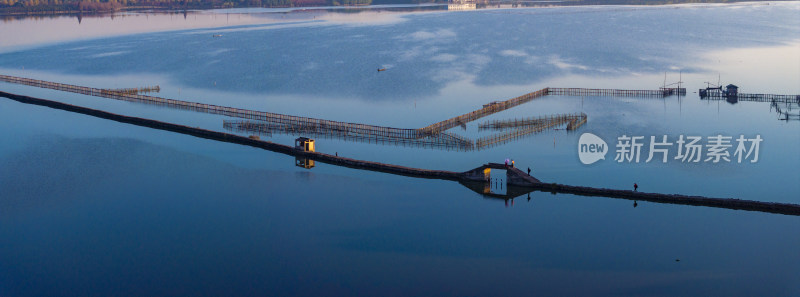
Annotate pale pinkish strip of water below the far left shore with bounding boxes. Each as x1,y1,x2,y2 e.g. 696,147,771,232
0,5,450,51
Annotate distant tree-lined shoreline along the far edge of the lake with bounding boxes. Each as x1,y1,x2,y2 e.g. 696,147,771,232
0,0,795,17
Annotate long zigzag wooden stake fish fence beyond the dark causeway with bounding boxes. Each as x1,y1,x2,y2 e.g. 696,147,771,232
0,75,668,150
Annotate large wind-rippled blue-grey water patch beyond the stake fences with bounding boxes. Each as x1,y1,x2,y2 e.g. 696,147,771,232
0,5,800,101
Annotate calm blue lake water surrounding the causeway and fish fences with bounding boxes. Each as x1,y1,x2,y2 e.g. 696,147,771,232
0,2,800,296
